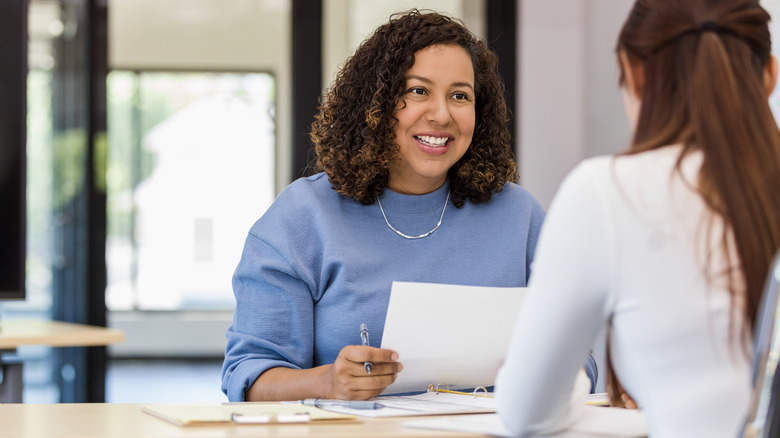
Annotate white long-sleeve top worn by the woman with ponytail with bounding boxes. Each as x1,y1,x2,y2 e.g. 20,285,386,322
496,146,752,438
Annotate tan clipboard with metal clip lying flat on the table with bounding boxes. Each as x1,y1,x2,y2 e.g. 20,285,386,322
141,402,357,426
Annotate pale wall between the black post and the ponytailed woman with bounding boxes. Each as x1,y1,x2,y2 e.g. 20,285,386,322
516,0,633,208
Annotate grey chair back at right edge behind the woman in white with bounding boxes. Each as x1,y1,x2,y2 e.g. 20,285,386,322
740,251,780,438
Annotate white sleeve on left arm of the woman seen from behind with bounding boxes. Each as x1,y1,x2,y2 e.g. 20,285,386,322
496,161,612,436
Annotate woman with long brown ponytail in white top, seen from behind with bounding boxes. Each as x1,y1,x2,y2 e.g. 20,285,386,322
496,0,780,438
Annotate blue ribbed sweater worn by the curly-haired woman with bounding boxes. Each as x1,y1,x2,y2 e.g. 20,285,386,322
222,173,544,401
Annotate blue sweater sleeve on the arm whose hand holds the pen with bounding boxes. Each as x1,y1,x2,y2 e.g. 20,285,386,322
222,233,314,402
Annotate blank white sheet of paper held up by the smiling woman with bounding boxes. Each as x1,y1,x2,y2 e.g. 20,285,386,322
382,282,526,394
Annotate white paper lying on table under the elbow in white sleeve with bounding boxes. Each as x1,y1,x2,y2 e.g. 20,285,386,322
404,406,647,438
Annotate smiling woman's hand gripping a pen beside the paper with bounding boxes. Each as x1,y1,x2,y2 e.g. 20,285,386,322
328,345,403,400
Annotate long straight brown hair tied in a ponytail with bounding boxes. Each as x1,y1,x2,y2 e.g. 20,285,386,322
608,0,780,408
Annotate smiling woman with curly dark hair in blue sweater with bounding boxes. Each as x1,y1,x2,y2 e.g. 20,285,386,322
222,10,572,401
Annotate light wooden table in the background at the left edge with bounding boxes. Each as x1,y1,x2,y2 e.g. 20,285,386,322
0,319,125,403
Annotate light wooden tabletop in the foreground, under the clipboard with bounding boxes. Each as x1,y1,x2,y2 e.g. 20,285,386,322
0,404,485,438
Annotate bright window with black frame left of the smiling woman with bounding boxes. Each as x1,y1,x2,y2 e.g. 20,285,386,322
106,71,275,310
